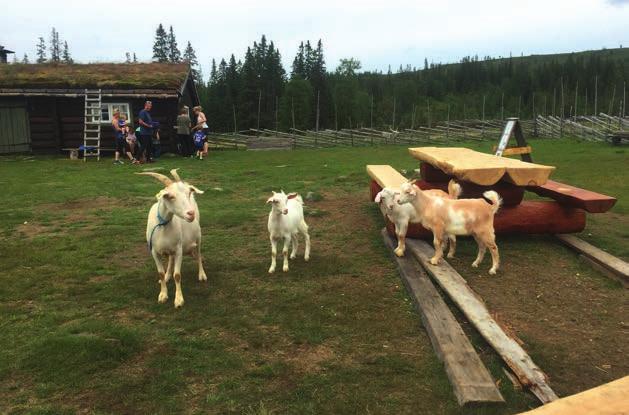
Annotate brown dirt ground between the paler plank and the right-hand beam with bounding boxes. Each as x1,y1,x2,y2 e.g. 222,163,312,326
449,237,629,396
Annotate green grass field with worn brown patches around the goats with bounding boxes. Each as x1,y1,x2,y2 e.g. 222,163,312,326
0,140,629,414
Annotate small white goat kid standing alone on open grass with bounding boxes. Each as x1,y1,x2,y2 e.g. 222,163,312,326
266,190,310,274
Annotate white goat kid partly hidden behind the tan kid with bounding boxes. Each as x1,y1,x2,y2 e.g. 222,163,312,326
374,180,461,258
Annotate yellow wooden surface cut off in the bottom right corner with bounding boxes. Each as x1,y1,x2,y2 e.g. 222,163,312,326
520,376,629,415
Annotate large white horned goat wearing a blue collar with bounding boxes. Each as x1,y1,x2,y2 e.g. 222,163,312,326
137,169,207,308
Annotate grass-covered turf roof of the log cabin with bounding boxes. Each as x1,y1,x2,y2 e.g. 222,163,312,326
0,63,188,90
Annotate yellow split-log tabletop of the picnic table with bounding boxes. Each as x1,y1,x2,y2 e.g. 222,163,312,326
408,147,555,186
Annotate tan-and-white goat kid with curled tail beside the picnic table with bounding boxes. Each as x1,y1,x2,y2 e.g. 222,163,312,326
399,183,502,274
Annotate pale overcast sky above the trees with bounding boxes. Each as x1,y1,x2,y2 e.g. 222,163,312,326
0,0,629,76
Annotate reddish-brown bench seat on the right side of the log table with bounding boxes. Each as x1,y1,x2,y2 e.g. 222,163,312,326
526,180,616,213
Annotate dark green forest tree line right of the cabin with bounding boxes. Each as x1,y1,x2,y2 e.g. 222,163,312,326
198,36,629,132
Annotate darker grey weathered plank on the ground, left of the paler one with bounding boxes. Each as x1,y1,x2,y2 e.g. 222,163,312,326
382,229,504,406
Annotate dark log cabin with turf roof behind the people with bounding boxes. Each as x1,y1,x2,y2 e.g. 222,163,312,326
0,63,199,154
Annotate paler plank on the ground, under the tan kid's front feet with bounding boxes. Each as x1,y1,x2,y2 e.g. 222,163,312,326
406,239,557,403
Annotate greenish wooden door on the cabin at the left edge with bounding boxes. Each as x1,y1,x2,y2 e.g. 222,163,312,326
0,98,31,154
